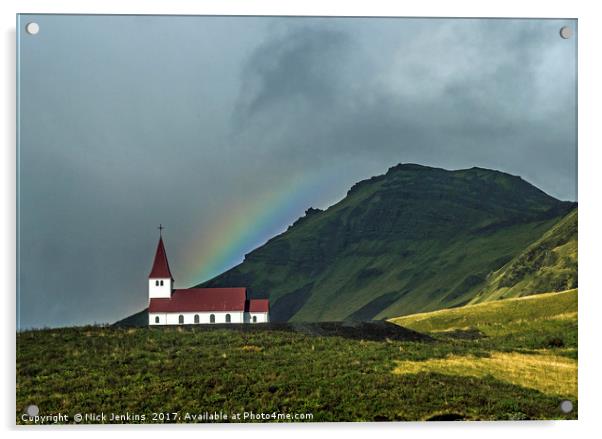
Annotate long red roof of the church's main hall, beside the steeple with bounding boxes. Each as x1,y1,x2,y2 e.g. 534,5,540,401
148,288,247,312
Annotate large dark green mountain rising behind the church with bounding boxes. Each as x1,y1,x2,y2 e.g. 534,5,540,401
202,164,576,321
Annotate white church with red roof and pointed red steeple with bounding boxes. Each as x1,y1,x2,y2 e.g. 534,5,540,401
148,230,270,326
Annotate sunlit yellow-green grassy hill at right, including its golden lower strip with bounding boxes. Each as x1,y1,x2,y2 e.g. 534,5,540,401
391,290,577,399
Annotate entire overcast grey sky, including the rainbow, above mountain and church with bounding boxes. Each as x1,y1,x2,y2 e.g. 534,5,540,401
18,15,577,328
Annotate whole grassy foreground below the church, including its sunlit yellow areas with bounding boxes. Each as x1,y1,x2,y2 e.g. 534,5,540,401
17,291,577,423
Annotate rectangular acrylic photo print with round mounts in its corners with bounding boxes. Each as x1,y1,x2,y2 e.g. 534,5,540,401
16,14,578,425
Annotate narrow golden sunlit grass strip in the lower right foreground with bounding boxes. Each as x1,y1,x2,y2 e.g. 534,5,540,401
393,352,577,399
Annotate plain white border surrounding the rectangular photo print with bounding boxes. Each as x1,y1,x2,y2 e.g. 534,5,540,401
0,0,602,439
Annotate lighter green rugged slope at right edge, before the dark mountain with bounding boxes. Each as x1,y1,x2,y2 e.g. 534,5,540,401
472,209,577,303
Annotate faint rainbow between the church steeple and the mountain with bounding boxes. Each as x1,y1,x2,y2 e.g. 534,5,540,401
180,172,331,285
